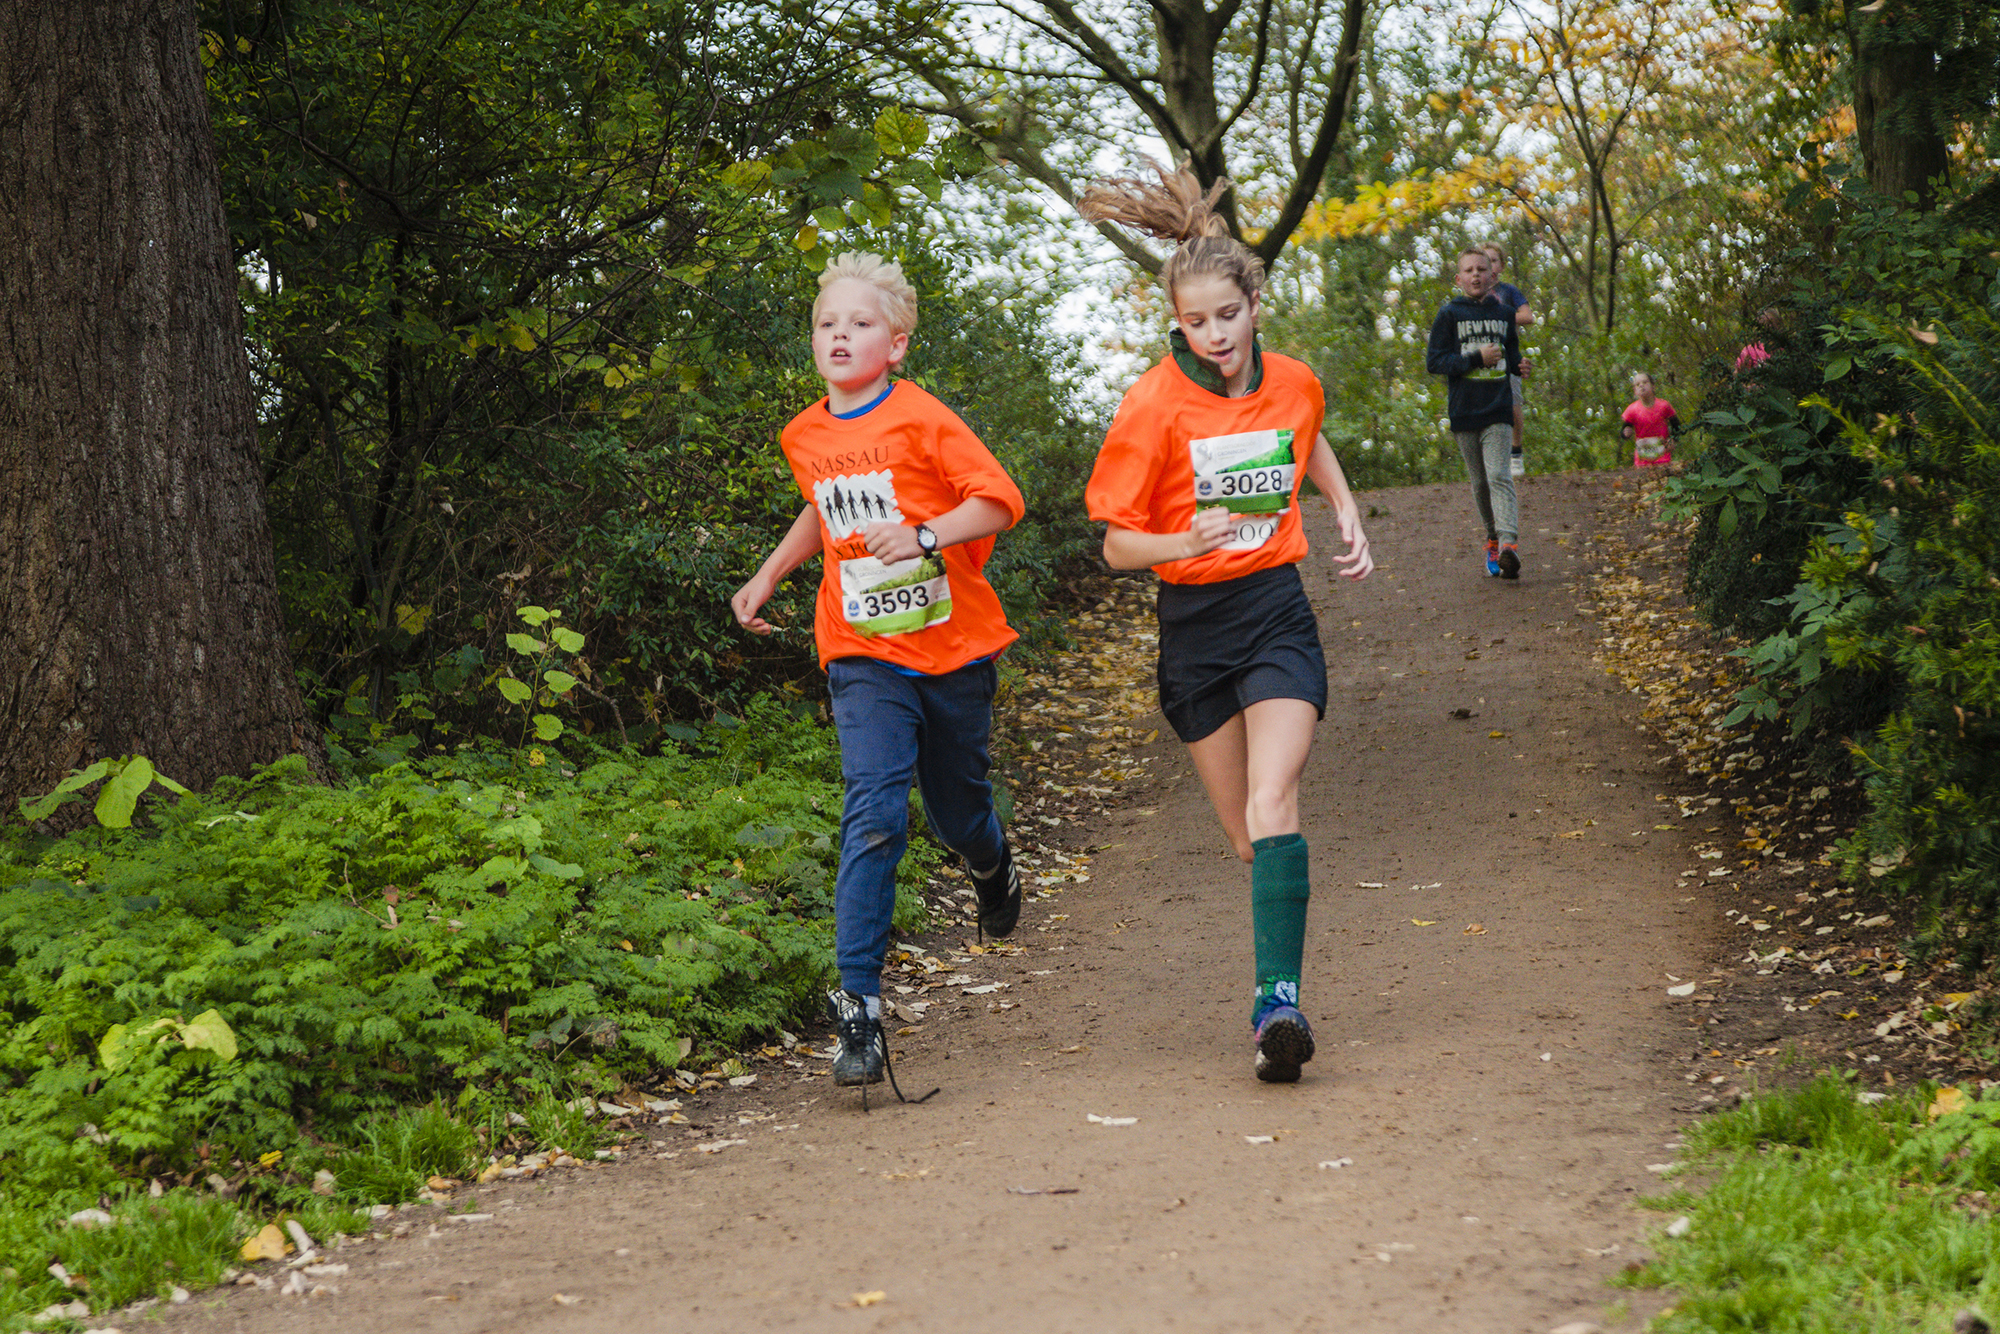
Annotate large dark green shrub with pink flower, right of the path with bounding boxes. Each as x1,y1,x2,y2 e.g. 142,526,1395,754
1670,193,2000,964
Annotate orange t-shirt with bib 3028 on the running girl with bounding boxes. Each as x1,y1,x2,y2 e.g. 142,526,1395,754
1084,352,1326,584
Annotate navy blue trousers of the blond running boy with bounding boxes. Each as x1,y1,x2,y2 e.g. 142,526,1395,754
826,658,1006,996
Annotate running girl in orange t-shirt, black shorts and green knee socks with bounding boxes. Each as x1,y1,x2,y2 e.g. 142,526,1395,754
1080,166,1374,1084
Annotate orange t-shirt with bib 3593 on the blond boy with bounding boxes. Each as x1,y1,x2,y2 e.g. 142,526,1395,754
782,380,1026,676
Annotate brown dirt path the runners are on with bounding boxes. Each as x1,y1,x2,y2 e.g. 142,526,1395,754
152,476,1718,1334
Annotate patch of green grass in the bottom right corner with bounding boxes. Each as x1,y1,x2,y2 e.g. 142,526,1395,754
1628,1074,2000,1334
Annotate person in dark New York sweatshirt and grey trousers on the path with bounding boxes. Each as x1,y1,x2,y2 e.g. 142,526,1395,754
1424,248,1520,578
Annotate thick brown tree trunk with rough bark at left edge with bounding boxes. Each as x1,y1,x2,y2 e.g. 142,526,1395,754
0,0,324,812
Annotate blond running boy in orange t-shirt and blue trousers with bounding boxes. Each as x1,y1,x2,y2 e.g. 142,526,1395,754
730,254,1022,1108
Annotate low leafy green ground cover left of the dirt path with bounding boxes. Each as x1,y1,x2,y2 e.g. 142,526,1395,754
0,702,934,1320
